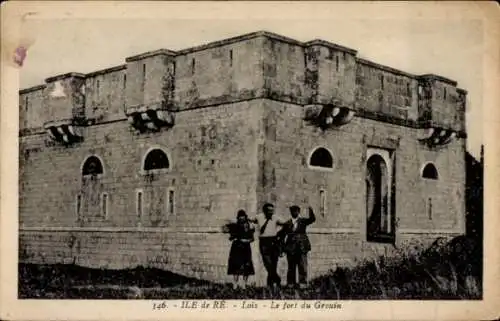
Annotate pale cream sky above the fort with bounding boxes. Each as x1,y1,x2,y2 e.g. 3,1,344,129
20,3,484,157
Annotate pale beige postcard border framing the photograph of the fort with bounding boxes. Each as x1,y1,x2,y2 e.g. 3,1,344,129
0,1,500,320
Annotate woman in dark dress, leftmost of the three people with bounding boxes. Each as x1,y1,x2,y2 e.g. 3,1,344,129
227,210,255,288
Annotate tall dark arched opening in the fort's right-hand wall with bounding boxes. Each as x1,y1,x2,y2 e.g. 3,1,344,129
365,153,395,243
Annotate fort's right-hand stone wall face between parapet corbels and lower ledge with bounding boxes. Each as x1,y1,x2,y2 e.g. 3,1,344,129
258,100,465,231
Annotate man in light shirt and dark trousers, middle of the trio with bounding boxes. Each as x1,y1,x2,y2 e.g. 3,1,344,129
250,203,285,287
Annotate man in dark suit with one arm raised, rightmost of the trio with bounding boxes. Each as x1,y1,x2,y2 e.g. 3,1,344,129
280,205,316,288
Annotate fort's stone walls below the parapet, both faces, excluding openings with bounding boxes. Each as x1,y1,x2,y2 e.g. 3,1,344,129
20,100,464,282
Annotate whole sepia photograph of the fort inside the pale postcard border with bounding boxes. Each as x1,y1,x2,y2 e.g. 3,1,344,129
2,1,498,318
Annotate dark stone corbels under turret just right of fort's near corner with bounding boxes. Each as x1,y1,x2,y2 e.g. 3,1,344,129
304,104,355,128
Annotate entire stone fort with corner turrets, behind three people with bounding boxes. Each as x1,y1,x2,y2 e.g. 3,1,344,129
19,31,467,282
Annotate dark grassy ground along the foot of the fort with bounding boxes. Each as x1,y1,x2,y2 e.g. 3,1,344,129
19,231,482,300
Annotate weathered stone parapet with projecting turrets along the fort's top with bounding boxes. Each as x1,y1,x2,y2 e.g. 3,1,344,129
19,32,466,136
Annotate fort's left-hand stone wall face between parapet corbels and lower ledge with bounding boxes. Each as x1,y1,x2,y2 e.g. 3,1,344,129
20,101,258,227
